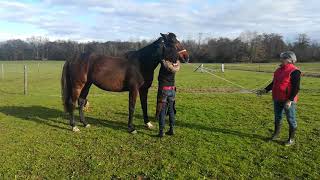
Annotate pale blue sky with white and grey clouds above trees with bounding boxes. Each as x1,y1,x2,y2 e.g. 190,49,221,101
0,0,320,41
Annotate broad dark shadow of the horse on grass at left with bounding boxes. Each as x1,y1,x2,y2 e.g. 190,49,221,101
0,106,131,131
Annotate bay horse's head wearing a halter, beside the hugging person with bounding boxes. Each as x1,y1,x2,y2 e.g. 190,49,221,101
160,33,189,63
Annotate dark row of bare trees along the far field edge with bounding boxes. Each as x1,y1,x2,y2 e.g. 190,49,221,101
0,32,320,63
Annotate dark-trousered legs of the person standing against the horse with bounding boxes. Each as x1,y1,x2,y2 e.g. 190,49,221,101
159,90,176,133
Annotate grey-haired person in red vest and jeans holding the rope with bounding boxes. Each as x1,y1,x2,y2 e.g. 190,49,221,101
257,51,301,146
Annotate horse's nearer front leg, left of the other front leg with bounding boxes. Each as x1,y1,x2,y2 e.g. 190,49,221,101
128,88,139,134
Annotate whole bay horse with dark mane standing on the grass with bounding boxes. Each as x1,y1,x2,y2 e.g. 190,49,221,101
61,33,189,133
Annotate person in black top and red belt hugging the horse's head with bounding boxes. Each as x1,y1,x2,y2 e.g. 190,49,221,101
156,47,180,138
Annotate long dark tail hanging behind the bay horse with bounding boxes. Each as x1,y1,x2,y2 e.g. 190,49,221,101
61,61,73,112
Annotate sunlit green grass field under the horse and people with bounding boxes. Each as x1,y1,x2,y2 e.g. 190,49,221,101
0,61,320,179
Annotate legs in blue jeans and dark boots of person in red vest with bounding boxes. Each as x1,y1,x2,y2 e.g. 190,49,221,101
273,101,297,140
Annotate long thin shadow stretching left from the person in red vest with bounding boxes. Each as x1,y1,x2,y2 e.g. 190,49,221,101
115,112,268,141
